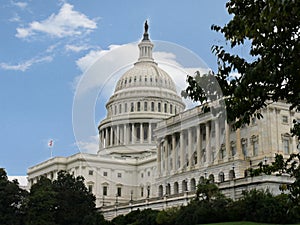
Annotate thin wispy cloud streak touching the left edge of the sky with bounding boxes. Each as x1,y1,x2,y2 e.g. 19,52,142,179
0,56,53,72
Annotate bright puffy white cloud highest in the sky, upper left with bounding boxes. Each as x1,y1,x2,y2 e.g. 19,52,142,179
16,3,97,38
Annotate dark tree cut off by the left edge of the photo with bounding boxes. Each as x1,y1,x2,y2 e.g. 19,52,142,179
0,168,27,225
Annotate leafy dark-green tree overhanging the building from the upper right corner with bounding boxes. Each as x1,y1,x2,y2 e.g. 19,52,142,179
187,0,300,139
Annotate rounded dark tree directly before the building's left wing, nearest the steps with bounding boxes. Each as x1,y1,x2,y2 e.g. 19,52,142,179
53,171,95,225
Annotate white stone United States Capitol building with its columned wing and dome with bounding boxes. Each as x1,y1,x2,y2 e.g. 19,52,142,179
28,22,300,218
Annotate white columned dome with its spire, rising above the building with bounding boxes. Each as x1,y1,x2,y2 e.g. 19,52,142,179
98,22,185,157
